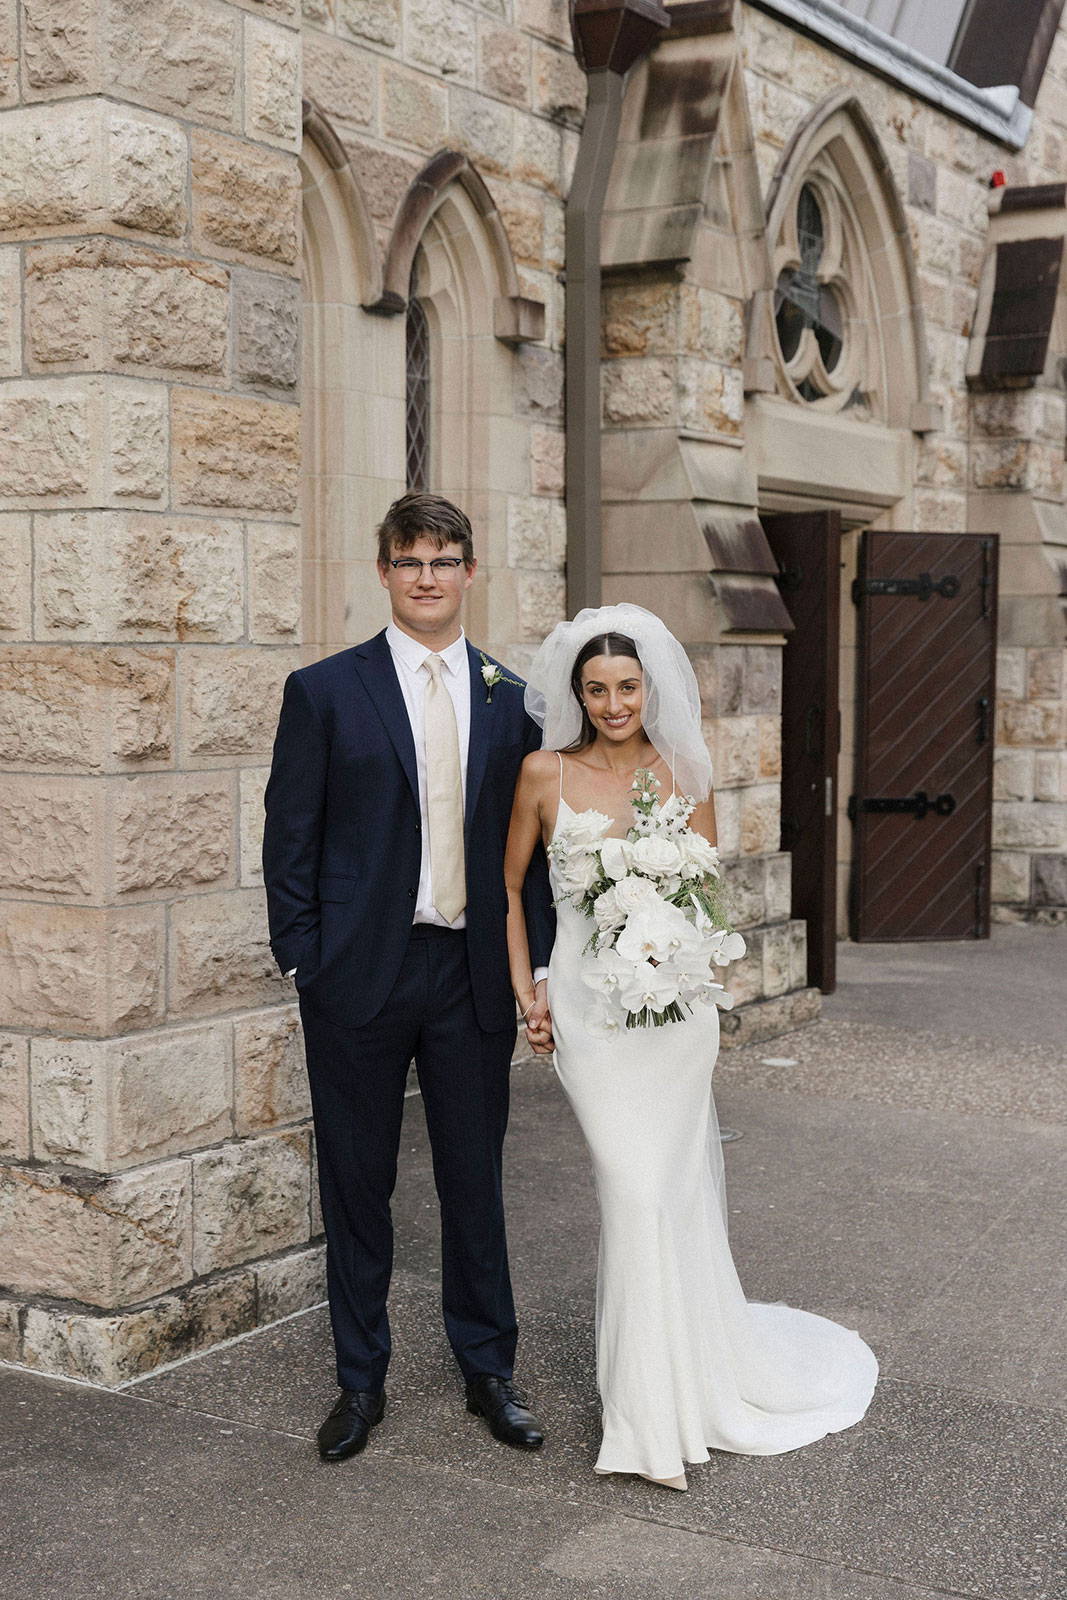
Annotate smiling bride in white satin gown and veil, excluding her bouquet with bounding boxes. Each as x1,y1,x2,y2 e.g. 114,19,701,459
506,605,878,1490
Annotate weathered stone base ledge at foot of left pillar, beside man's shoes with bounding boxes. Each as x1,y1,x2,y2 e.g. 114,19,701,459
0,1243,326,1389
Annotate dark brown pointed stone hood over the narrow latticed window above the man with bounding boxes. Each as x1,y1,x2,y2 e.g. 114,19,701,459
365,150,544,344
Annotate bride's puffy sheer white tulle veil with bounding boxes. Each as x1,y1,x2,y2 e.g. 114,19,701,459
526,603,712,800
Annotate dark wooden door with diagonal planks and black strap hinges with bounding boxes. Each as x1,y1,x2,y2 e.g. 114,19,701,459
849,531,997,939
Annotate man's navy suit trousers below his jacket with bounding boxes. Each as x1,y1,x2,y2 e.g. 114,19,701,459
301,925,517,1389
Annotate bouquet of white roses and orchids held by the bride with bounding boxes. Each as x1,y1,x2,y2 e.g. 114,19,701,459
549,768,745,1038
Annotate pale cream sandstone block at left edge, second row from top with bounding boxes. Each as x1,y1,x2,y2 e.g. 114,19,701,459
0,102,101,237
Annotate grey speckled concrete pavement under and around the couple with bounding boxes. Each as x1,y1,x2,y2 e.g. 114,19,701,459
0,926,1067,1600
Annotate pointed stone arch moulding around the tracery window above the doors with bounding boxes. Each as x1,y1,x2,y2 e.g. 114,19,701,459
745,90,937,432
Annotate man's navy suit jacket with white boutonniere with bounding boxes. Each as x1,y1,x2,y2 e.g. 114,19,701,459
262,630,555,1032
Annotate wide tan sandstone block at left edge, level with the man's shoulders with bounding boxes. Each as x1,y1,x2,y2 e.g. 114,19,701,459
0,645,174,771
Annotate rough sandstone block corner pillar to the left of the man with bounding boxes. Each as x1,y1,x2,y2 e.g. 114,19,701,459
0,0,322,1382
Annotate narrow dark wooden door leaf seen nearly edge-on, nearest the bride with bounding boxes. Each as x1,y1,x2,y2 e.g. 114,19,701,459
761,510,841,994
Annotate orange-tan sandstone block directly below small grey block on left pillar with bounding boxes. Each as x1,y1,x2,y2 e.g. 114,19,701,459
171,389,301,512
